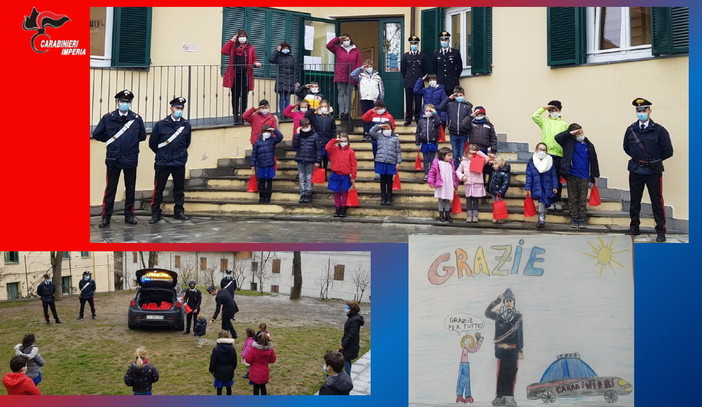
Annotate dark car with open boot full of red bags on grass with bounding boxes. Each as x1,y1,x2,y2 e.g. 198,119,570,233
127,268,185,330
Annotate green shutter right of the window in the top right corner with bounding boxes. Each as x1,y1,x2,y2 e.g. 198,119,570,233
651,7,690,56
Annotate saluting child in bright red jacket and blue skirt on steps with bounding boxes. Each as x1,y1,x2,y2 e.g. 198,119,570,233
324,133,358,218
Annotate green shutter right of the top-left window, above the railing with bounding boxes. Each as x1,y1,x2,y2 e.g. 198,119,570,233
112,7,152,67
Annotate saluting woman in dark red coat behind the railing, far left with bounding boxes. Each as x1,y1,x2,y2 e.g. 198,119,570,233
222,30,261,124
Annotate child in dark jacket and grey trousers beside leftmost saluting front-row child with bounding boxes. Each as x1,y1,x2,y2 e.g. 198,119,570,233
293,117,322,203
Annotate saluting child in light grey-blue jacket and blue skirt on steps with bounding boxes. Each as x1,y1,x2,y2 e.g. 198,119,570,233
369,123,402,205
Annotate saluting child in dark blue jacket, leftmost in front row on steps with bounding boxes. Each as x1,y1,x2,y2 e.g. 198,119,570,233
251,125,283,204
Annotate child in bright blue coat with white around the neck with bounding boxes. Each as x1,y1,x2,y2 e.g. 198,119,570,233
524,142,558,229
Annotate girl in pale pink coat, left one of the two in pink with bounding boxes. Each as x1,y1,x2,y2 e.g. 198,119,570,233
427,147,458,223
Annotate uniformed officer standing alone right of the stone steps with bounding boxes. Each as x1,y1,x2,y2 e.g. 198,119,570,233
624,98,673,242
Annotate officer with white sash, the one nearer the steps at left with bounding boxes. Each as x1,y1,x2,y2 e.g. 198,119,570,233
149,97,190,223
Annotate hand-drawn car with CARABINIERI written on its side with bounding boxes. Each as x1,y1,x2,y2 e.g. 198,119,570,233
527,353,634,403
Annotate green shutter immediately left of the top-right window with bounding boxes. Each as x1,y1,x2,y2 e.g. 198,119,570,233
546,7,587,66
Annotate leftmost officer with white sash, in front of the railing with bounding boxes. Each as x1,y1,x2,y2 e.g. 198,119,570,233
93,90,146,228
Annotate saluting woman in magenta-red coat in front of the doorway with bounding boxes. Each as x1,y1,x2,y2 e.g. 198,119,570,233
327,34,361,119
